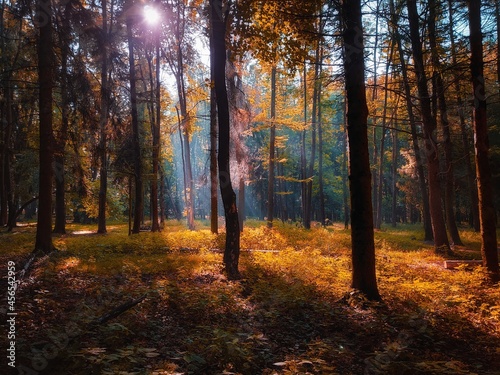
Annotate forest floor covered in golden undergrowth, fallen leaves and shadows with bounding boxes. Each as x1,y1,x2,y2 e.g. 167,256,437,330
0,222,500,375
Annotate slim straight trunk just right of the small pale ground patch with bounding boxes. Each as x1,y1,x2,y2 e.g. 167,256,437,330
97,0,109,233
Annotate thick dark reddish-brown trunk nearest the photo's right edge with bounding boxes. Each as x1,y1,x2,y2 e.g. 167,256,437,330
468,0,500,282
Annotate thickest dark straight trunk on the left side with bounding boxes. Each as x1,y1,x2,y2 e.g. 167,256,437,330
35,0,54,254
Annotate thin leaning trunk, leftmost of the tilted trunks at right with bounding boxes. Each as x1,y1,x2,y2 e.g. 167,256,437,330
389,0,434,241
